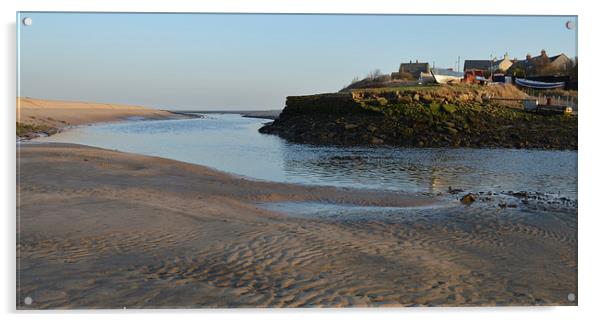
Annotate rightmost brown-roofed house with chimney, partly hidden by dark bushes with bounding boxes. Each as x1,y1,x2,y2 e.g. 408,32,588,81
507,49,572,76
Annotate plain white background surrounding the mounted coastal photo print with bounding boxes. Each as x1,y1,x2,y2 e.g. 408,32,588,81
0,0,602,322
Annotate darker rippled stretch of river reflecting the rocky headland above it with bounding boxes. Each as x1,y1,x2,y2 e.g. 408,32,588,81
283,145,577,198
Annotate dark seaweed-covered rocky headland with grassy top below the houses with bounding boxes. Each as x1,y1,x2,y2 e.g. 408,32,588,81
260,85,577,149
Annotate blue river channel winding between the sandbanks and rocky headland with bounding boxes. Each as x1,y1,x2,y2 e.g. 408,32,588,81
37,114,577,200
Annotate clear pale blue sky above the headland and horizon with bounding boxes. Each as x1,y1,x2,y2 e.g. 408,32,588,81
17,13,577,110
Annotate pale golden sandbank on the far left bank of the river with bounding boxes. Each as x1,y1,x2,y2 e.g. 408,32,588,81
17,97,175,129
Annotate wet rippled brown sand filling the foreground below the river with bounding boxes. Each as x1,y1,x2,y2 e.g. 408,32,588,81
16,144,577,309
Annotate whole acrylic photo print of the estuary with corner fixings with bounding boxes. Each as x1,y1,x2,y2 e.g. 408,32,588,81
16,12,578,309
